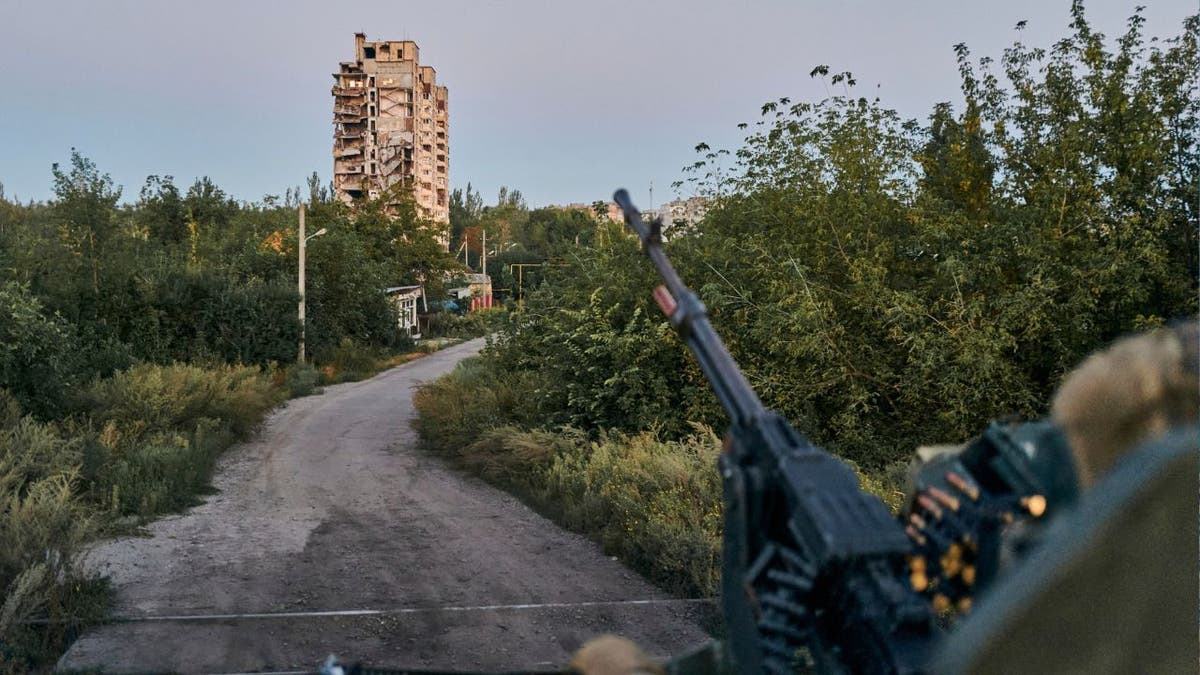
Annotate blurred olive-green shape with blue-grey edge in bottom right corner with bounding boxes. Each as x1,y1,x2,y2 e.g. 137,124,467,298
931,425,1200,675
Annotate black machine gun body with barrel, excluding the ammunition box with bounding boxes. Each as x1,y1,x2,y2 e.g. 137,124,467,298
613,190,938,674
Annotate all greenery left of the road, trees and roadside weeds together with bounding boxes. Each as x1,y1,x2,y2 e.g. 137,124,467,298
0,157,454,673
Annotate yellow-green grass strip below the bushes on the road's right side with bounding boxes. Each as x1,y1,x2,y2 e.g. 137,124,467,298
413,357,902,597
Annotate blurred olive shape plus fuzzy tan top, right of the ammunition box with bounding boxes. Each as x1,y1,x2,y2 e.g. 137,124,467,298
934,319,1200,674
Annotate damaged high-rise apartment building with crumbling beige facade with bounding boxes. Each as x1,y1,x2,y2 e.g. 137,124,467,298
334,32,450,244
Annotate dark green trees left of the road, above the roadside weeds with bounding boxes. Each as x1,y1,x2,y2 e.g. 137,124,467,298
0,156,452,418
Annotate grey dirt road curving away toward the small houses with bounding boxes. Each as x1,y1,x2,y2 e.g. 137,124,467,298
59,341,704,673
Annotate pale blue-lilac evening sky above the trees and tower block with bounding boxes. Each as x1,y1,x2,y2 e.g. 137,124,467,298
0,0,1198,208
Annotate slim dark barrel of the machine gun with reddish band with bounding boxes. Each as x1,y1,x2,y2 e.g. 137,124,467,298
613,190,766,424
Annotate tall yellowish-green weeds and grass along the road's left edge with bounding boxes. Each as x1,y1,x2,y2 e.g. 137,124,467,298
0,364,278,673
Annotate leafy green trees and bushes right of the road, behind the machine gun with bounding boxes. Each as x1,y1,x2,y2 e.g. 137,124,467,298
418,2,1200,590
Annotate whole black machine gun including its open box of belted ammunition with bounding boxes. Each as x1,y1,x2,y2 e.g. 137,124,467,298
613,184,1113,674
